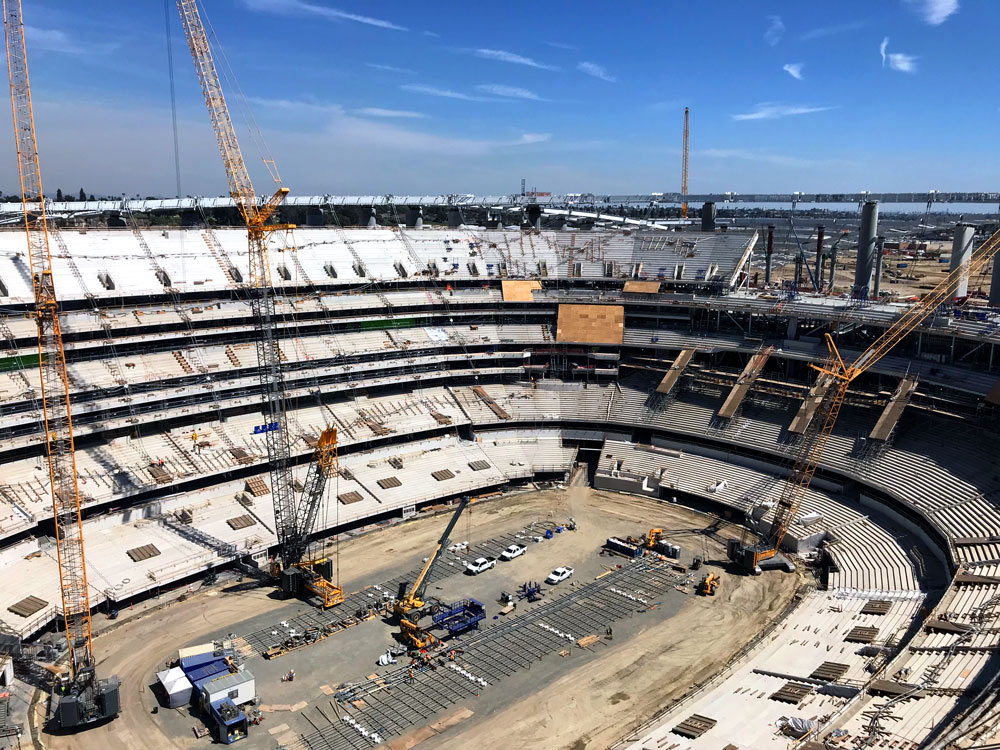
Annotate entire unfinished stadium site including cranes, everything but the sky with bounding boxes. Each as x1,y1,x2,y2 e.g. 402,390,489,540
0,0,1000,750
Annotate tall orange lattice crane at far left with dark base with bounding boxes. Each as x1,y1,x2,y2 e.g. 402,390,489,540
3,0,119,730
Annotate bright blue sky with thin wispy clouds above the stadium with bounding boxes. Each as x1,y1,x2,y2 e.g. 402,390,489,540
0,0,1000,195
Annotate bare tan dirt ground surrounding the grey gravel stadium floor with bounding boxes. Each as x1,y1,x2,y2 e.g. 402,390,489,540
43,487,798,750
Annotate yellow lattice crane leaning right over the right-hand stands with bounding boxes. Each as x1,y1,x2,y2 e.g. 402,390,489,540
727,230,1000,574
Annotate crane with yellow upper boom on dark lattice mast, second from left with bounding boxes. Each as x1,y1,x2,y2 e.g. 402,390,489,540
177,0,343,597
